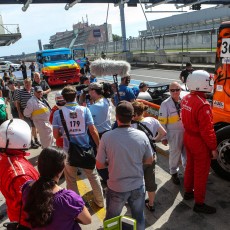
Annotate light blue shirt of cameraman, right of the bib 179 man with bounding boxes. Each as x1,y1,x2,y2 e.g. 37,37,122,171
89,98,112,133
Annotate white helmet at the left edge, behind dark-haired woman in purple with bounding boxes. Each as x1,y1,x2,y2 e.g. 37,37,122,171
0,119,31,149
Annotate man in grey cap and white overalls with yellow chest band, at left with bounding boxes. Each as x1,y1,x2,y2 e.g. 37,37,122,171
23,86,53,148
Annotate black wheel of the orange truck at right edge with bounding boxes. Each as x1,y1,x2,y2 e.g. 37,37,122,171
211,126,230,181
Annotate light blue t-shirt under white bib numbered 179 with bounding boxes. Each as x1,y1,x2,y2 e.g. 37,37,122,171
53,102,94,151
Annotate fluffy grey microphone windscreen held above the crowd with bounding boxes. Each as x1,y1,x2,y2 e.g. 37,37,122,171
90,59,131,77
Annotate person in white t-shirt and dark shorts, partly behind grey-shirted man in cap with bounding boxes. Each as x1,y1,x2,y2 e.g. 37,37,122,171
132,101,166,212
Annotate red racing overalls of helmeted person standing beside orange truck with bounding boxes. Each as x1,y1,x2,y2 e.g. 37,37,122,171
181,92,217,204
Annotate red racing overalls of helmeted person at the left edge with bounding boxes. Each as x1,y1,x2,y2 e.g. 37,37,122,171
0,150,39,227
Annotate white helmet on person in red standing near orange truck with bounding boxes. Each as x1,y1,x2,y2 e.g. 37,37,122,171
186,70,214,93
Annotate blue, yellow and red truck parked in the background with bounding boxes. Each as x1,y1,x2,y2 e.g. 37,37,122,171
36,48,80,86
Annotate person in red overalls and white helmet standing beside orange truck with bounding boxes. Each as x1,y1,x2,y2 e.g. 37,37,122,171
181,70,218,214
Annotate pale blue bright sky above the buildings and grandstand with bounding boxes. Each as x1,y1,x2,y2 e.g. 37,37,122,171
0,3,214,56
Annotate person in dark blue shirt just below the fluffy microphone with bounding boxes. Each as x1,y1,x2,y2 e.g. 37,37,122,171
112,76,136,106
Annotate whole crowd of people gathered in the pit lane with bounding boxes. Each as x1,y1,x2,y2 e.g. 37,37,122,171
0,61,217,230
